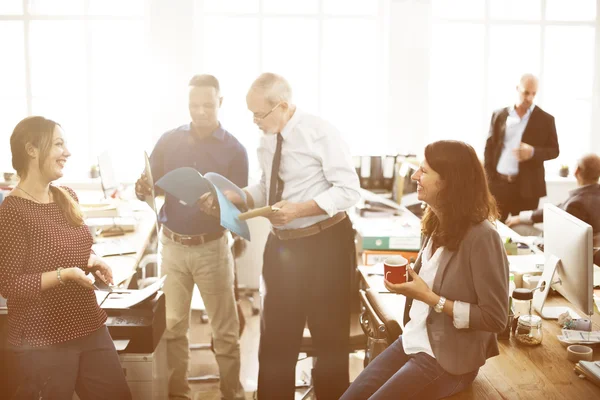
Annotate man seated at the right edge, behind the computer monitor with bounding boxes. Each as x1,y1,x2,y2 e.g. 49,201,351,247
506,154,600,241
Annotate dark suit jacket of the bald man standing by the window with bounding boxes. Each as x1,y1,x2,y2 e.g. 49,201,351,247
484,106,559,199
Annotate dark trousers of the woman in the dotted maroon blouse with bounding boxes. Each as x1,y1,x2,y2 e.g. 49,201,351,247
12,326,131,400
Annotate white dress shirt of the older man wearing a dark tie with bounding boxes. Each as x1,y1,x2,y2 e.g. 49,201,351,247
247,109,360,229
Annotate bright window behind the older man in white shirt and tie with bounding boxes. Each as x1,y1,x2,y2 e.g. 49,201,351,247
194,0,386,177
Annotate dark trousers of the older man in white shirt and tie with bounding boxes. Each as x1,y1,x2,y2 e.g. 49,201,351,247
258,218,356,400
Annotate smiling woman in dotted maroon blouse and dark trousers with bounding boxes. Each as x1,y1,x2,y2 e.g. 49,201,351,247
0,117,131,400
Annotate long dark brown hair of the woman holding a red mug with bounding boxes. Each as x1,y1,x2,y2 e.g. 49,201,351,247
421,140,498,251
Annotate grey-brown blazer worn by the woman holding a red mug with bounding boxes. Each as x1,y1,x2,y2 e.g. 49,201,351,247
404,221,509,375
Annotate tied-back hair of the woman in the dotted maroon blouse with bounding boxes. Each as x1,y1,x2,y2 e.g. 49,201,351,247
10,116,84,226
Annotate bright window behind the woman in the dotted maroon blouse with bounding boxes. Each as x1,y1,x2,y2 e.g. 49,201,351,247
0,0,152,180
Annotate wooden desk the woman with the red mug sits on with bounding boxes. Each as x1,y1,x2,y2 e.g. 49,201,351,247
359,267,600,399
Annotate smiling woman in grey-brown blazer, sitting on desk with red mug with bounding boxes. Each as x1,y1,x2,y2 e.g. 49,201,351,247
341,141,509,400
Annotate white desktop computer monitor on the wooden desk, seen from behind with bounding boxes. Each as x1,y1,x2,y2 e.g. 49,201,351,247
534,204,594,319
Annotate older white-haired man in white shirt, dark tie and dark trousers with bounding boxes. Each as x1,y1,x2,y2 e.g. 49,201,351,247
240,73,360,400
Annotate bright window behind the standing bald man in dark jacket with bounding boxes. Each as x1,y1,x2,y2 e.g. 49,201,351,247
430,0,598,173
